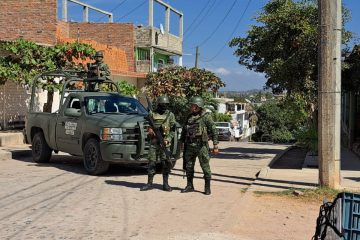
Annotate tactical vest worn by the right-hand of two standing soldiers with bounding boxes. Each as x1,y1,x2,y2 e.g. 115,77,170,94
186,114,208,142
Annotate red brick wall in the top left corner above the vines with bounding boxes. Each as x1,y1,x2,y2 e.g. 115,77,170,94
0,0,57,44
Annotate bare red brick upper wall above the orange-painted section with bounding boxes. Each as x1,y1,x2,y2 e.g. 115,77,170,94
69,23,135,72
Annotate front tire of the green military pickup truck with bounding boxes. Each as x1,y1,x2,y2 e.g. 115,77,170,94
84,138,110,175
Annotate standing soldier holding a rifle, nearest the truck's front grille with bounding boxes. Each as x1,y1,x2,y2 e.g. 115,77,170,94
140,96,175,192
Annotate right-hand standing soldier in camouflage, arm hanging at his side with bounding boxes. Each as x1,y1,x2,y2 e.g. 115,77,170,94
181,96,219,195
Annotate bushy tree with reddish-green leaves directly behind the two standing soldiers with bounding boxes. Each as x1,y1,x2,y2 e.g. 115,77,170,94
145,66,225,123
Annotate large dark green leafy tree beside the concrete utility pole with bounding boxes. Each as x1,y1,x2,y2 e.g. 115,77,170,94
229,0,351,106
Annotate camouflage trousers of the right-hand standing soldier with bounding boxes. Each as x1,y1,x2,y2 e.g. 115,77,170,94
184,142,211,179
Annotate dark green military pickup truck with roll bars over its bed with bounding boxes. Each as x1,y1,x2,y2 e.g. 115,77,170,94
25,71,181,175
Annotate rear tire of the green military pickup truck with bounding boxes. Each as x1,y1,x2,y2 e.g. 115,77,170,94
31,132,52,163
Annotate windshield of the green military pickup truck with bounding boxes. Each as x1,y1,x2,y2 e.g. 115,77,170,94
85,96,147,115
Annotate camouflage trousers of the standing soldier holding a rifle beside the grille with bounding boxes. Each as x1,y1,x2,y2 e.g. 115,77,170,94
148,144,171,176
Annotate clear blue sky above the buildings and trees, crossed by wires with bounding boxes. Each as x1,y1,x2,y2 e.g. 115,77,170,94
59,0,360,91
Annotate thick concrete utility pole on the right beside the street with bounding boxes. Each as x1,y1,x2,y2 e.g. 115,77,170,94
318,0,342,188
